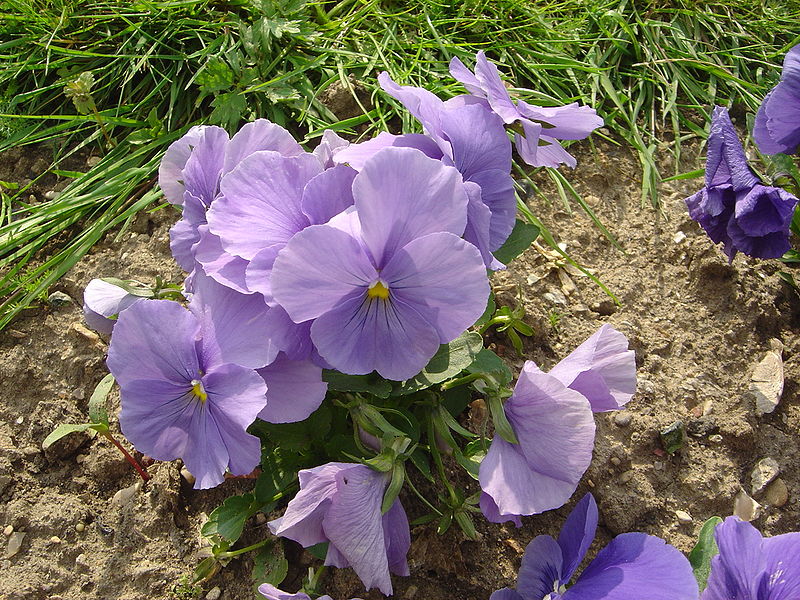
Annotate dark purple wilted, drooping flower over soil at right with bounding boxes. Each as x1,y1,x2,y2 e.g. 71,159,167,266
686,106,798,261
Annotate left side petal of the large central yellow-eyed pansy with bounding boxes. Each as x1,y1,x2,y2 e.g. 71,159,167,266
270,225,377,323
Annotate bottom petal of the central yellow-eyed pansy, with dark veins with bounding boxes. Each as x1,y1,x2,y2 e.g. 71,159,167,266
311,288,440,381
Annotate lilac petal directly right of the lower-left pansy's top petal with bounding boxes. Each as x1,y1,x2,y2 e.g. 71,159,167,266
189,271,278,369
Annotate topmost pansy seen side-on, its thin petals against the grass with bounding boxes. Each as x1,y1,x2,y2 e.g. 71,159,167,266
450,51,603,167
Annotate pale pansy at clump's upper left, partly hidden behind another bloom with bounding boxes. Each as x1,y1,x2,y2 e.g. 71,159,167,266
159,119,303,282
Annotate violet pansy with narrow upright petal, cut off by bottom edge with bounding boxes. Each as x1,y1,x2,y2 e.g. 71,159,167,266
490,494,700,600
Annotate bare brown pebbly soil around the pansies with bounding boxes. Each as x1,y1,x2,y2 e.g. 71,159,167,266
0,135,800,600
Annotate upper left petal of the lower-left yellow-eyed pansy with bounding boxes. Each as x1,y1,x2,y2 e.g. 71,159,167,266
107,300,200,385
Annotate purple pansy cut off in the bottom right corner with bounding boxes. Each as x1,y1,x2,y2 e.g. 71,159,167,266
701,517,800,600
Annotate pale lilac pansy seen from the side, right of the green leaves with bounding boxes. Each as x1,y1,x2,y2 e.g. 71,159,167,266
478,325,636,527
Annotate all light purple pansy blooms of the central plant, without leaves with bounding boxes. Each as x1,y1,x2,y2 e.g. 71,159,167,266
85,53,608,595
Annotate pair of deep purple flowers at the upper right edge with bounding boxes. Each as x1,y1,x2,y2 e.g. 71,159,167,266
686,46,800,261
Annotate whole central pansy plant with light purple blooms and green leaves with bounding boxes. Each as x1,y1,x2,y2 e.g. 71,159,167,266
53,53,636,598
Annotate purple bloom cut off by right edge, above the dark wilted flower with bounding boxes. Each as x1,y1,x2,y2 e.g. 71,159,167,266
753,44,800,154
